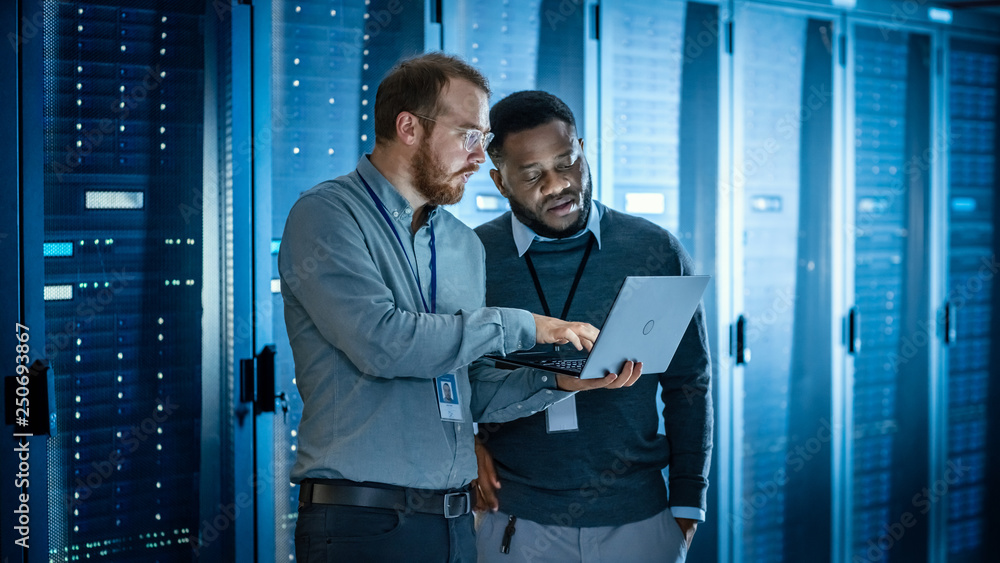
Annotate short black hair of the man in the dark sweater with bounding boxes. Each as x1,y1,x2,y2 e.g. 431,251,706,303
489,90,576,165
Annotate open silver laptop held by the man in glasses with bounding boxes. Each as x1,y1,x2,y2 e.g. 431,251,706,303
486,276,711,379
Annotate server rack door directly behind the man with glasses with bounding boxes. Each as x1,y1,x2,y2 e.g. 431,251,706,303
254,0,429,561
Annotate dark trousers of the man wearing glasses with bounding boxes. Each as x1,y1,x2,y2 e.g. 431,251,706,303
295,504,476,563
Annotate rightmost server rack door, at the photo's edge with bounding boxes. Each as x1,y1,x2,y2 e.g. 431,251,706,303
942,38,1000,562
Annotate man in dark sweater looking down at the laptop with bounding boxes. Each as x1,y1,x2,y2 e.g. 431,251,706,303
476,91,712,563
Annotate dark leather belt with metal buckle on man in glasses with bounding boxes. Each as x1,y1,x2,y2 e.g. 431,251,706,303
299,480,476,518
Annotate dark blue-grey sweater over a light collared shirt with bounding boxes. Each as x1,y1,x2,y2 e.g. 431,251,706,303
476,208,712,527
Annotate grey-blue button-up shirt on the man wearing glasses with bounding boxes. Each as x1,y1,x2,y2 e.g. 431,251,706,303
278,156,570,489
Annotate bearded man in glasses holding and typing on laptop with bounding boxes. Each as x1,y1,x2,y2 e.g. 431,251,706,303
278,54,641,562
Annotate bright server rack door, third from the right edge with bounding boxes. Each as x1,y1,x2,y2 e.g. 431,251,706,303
730,3,836,562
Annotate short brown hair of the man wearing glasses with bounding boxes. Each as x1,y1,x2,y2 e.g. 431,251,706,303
374,53,490,144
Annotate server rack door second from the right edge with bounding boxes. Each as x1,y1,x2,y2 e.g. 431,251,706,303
848,23,938,561
